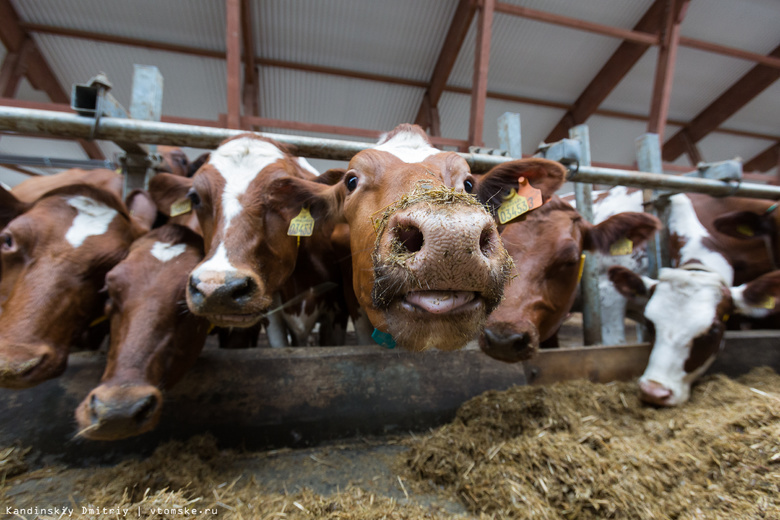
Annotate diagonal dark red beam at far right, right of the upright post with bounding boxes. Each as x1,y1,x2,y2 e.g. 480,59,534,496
662,46,780,161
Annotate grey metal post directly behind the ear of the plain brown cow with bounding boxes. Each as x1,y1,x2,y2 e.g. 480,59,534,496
569,125,601,345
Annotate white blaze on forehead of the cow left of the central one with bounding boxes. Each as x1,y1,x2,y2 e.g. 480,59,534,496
209,137,285,230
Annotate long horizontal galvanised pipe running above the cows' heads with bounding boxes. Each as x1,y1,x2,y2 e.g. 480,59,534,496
0,106,780,199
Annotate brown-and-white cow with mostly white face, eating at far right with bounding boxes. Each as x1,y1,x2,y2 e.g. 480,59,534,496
594,188,777,406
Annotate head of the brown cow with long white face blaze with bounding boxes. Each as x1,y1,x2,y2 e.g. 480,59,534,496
150,134,331,327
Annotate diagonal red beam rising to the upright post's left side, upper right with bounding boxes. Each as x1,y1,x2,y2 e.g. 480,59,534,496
545,0,665,143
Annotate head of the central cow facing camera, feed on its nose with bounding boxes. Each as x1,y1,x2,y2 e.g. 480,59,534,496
268,125,565,350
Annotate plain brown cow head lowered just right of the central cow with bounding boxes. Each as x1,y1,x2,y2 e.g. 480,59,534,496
479,197,661,362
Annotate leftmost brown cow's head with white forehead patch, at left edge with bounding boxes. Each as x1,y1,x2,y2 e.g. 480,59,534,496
0,184,148,388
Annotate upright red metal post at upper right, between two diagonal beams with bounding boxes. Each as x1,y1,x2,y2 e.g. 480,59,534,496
647,0,690,143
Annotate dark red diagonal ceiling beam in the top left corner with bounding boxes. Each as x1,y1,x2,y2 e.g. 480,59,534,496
0,0,105,159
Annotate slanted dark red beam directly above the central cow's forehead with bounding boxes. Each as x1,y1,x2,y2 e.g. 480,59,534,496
414,0,477,128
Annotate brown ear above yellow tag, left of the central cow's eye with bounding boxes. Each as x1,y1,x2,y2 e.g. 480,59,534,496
266,177,344,222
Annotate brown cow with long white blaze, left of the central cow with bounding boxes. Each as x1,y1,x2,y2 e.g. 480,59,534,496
150,134,348,347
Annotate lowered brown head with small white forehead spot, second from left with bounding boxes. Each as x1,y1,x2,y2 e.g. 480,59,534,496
76,224,209,440
